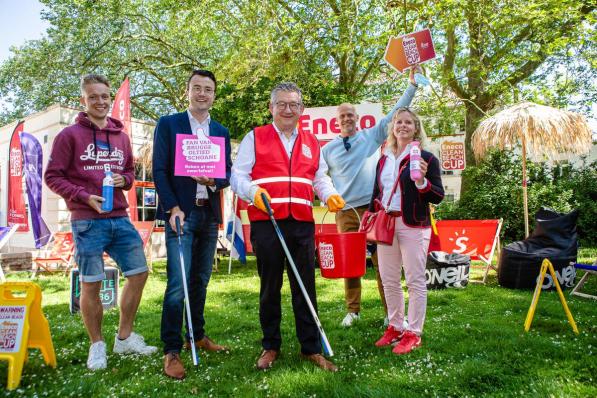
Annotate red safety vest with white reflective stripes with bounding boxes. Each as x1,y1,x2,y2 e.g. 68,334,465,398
248,124,320,222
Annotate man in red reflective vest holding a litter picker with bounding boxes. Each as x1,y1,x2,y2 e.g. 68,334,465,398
230,83,344,372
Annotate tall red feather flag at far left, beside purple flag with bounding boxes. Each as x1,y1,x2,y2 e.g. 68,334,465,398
7,121,29,232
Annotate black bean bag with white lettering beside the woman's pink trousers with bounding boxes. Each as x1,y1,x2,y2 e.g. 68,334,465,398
425,251,471,289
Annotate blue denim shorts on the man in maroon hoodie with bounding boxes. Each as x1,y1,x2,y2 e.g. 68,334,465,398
71,217,148,282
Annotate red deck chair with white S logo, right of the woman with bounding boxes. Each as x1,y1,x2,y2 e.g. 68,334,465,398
436,218,503,284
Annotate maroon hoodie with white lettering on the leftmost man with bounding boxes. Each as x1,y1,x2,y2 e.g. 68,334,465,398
44,112,135,220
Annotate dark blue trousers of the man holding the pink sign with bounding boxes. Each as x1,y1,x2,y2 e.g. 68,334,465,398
161,207,218,353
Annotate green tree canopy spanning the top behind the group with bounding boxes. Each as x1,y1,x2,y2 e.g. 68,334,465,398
0,0,596,151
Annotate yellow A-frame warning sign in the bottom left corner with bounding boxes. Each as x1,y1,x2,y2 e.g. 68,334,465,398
0,282,56,390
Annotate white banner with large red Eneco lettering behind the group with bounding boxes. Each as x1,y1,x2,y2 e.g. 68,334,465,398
299,104,384,141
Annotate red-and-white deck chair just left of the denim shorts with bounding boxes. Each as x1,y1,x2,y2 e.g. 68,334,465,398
31,232,75,278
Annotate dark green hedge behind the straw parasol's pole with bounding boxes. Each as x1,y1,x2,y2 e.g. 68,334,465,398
436,151,597,245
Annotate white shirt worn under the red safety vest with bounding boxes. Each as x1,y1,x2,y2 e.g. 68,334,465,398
230,124,338,202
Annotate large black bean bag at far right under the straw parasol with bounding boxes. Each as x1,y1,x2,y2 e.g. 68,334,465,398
498,208,578,290
